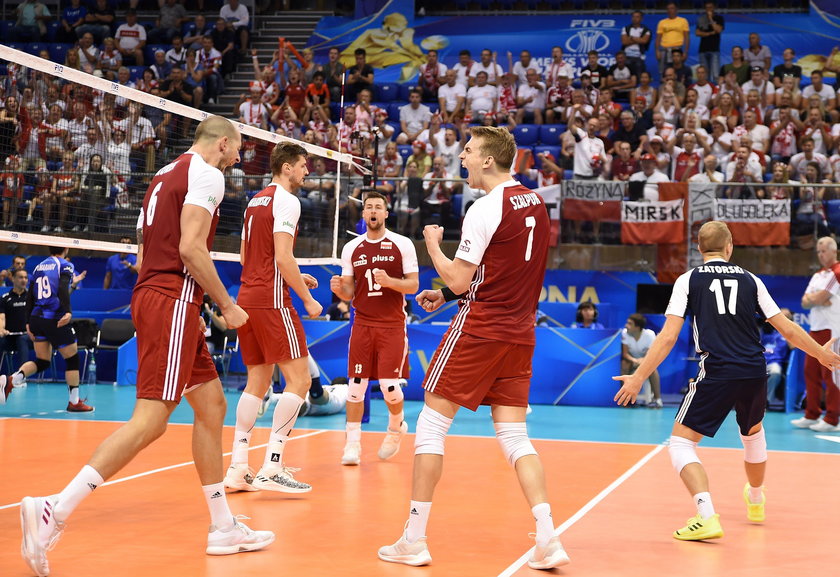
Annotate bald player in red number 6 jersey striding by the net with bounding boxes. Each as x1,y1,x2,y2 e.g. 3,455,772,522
21,116,274,576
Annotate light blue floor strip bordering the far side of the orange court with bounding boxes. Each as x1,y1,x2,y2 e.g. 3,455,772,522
0,383,840,454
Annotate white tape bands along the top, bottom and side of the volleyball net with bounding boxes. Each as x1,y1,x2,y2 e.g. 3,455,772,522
0,44,371,265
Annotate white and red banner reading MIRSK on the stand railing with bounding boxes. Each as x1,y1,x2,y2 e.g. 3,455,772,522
621,198,685,244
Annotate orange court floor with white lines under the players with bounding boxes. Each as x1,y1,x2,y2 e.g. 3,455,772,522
0,410,840,577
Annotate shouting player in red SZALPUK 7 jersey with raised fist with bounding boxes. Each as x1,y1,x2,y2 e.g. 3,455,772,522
379,126,569,569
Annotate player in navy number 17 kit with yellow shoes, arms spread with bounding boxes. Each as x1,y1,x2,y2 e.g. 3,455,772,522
613,221,840,541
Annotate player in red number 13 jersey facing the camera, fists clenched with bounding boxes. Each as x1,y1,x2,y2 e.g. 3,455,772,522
330,192,419,465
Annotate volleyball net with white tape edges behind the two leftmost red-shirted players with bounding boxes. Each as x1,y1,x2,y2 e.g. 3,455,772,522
0,45,370,264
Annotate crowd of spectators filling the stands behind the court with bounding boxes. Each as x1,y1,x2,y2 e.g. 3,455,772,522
0,0,840,237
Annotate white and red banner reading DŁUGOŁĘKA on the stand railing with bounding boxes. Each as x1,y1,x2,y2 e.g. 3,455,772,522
714,198,790,246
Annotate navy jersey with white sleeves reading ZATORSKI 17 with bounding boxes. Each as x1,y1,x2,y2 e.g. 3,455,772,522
665,259,779,380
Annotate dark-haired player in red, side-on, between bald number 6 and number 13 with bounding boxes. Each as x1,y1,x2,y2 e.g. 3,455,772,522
225,142,321,493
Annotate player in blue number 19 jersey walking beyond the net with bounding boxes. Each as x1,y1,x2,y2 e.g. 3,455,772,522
0,246,93,413
